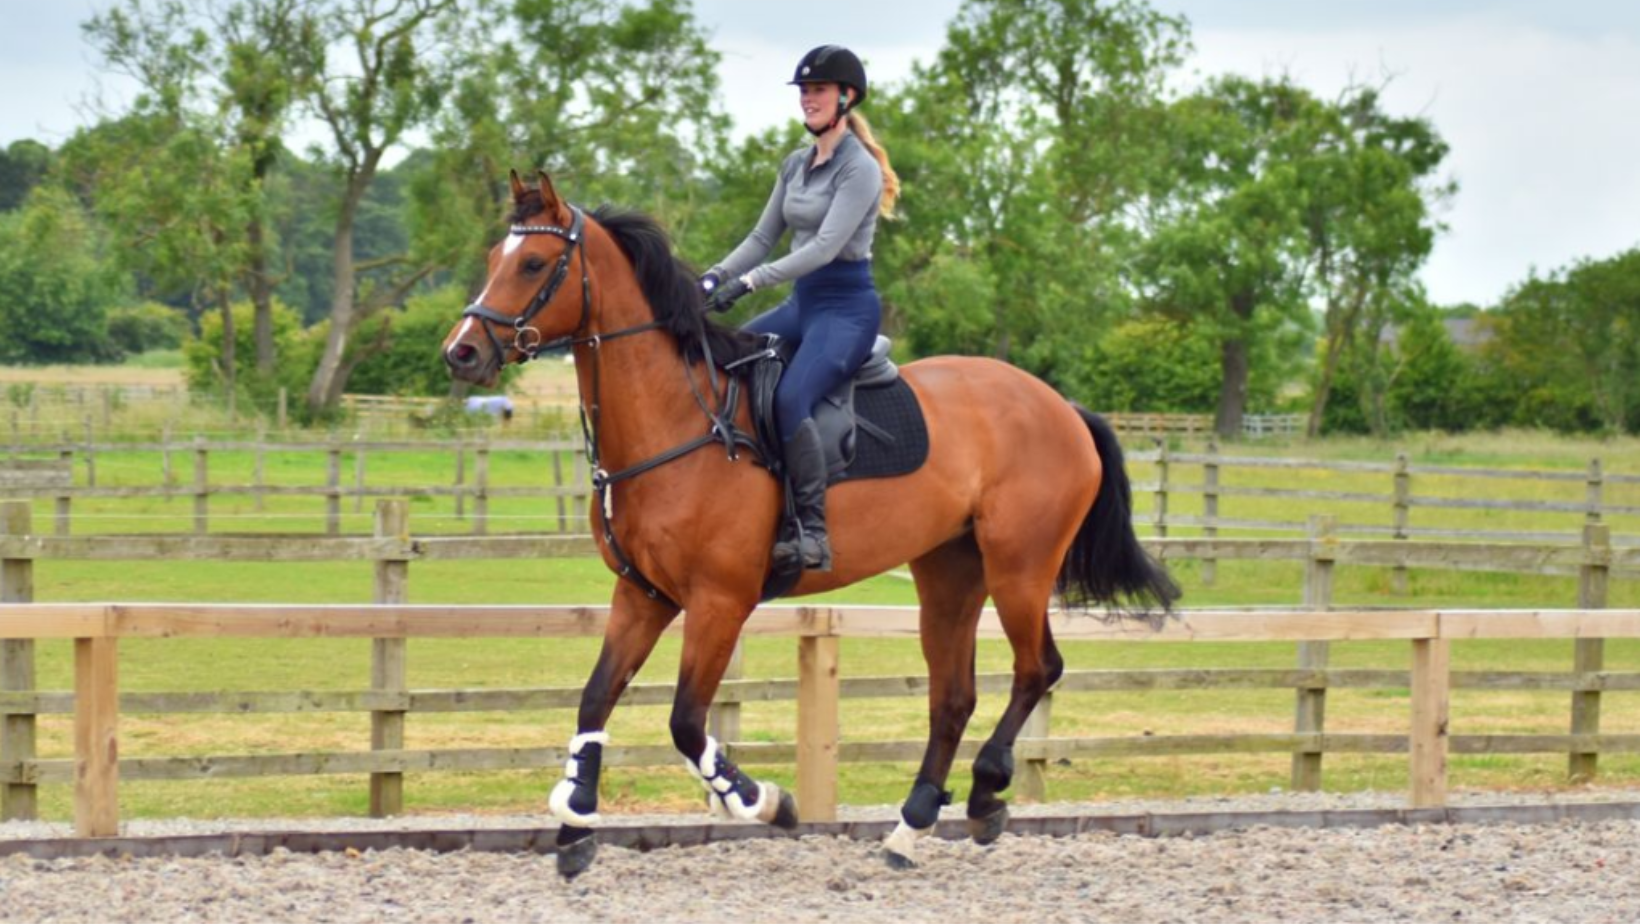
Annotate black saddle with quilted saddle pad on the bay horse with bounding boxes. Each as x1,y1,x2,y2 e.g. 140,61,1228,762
746,335,928,601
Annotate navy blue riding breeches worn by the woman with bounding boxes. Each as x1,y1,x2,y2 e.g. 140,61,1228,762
746,259,882,440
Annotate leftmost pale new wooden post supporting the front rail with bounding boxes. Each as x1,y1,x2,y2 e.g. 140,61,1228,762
74,638,120,837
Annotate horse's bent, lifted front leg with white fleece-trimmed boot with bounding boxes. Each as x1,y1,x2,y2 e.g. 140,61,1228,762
672,601,797,830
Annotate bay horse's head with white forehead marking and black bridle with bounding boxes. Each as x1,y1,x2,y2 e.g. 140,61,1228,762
444,171,590,387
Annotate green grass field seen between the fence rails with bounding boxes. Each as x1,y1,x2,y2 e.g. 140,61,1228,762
3,365,1640,819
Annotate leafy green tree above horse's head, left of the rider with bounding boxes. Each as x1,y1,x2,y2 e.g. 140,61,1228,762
423,0,731,303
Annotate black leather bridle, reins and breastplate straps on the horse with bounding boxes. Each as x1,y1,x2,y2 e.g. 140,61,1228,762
461,205,761,601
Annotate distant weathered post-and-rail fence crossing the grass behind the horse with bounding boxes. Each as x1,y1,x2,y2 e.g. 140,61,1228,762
0,438,1640,554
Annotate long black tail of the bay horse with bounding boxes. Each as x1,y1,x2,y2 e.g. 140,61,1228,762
1055,405,1179,617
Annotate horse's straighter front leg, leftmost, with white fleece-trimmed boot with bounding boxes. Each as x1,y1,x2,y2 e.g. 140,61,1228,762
548,581,677,878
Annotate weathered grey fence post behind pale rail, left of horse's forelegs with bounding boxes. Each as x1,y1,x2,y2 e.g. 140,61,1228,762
371,497,410,817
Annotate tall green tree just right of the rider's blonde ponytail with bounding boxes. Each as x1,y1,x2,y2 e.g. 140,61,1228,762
871,0,1187,375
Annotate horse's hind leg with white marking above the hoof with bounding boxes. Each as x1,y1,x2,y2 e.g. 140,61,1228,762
886,533,986,867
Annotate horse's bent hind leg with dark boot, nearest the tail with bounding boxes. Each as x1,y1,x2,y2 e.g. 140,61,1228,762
968,547,1064,844
